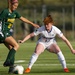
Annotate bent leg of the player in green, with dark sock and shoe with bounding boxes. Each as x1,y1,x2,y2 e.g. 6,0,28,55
3,36,19,67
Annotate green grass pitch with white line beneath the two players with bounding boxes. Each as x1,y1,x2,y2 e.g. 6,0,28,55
0,42,75,75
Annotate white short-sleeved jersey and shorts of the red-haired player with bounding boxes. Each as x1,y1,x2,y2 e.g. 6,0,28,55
34,26,63,48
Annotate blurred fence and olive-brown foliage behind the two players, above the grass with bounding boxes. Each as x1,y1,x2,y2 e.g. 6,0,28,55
0,0,75,41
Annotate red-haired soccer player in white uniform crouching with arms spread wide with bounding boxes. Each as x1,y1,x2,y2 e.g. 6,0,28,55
19,15,75,73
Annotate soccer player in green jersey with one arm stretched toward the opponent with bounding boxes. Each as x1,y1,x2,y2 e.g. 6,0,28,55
0,0,39,72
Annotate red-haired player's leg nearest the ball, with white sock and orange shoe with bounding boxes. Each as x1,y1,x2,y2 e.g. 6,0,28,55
25,44,44,73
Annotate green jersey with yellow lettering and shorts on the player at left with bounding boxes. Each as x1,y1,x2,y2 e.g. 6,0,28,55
0,8,21,40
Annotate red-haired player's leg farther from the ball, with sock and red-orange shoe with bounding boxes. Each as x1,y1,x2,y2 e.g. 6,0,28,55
49,44,69,72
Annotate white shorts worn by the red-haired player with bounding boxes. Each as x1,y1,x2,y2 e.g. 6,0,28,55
37,39,57,49
